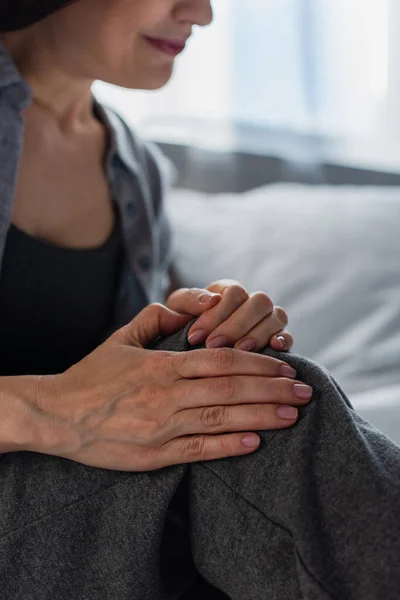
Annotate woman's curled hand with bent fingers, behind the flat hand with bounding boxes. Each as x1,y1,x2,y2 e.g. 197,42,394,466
166,279,293,352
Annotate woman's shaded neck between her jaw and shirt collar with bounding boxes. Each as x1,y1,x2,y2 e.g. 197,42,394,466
2,28,93,126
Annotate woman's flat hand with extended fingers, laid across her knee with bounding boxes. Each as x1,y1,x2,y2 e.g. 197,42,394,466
33,304,312,471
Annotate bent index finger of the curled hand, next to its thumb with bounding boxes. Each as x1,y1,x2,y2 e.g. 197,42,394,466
188,285,249,346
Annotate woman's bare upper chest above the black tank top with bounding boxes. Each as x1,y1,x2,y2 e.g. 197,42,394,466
12,109,114,248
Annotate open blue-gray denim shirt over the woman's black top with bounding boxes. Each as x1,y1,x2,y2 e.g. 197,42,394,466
0,42,170,333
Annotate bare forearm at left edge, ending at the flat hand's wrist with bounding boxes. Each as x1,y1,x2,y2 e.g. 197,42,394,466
0,376,43,454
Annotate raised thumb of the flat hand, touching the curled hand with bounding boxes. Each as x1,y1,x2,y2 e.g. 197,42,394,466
109,304,192,348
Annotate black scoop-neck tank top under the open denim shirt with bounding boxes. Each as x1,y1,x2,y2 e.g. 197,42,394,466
0,221,123,375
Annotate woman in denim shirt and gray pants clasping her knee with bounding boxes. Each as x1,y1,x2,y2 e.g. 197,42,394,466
0,0,398,600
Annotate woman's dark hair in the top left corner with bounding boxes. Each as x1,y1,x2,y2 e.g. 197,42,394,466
0,0,76,33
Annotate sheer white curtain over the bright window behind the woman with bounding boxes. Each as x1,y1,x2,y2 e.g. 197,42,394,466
96,0,400,144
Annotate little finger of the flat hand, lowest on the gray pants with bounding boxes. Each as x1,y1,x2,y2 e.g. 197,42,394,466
159,432,260,468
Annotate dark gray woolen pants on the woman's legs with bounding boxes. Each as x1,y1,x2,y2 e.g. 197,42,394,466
0,325,400,600
